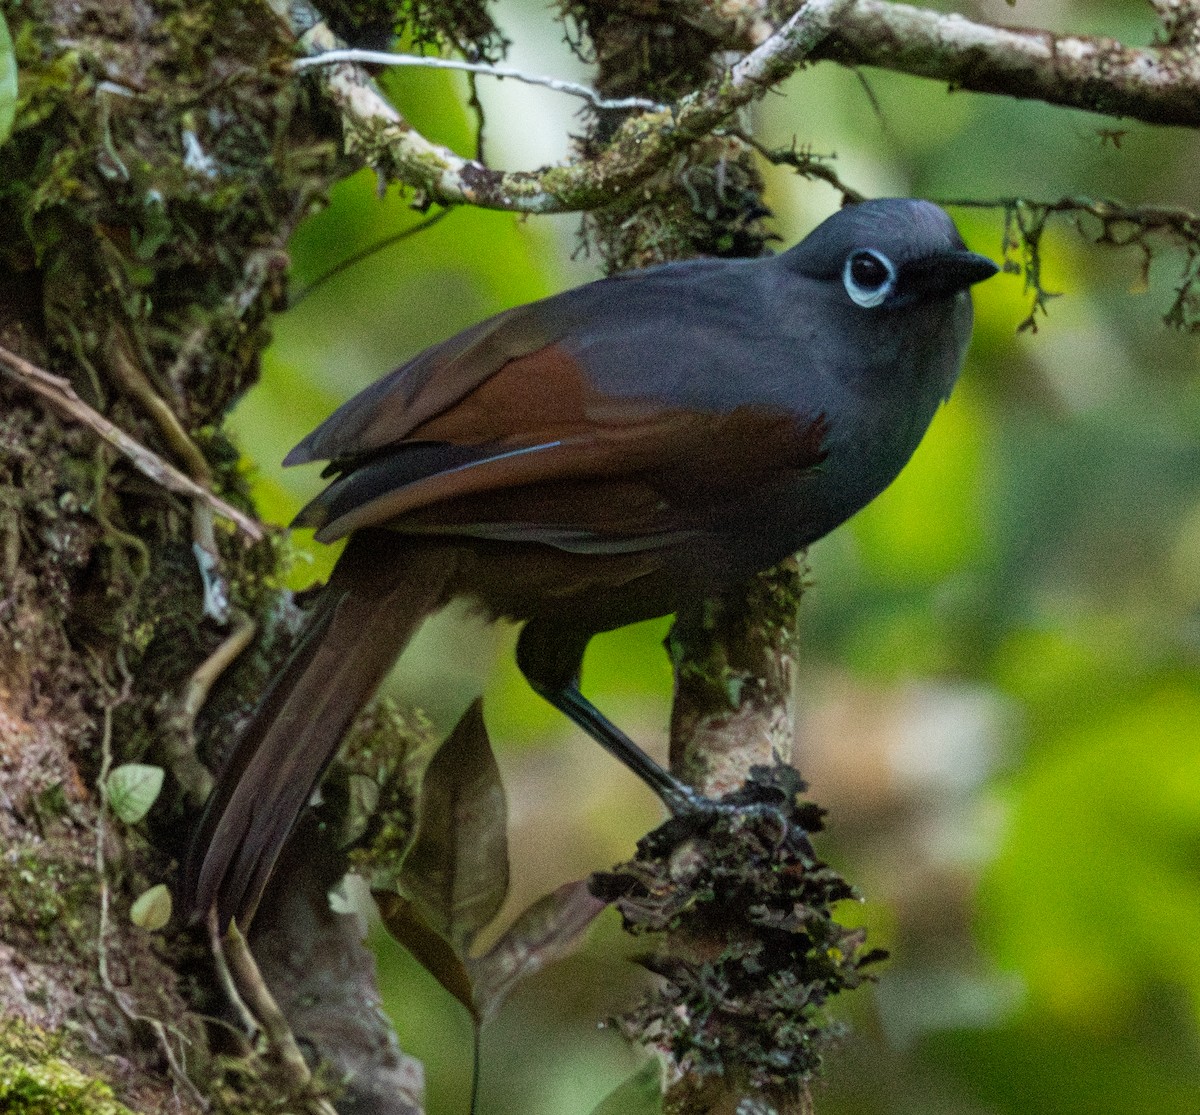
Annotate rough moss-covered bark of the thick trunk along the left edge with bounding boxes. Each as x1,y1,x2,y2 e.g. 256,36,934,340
0,0,364,1113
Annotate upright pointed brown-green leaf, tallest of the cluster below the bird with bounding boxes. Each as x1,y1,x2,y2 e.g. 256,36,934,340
398,700,509,957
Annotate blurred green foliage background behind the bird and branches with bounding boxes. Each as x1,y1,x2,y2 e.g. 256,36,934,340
233,0,1200,1115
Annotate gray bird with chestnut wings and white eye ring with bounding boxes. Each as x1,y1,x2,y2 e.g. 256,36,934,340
182,198,998,929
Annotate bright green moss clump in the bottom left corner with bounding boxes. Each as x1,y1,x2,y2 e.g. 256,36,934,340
0,1020,133,1115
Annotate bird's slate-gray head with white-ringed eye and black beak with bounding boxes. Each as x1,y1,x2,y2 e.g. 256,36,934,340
780,198,998,312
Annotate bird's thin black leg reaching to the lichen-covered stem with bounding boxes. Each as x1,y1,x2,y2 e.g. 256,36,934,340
517,621,714,816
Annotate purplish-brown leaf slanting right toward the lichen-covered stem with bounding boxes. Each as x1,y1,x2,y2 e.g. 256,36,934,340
468,880,607,1019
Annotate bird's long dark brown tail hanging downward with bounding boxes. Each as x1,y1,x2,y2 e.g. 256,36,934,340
182,532,455,930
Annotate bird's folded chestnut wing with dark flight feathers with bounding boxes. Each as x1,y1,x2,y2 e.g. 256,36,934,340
295,344,824,552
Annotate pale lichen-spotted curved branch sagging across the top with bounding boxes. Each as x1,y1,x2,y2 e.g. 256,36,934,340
266,0,1200,214
